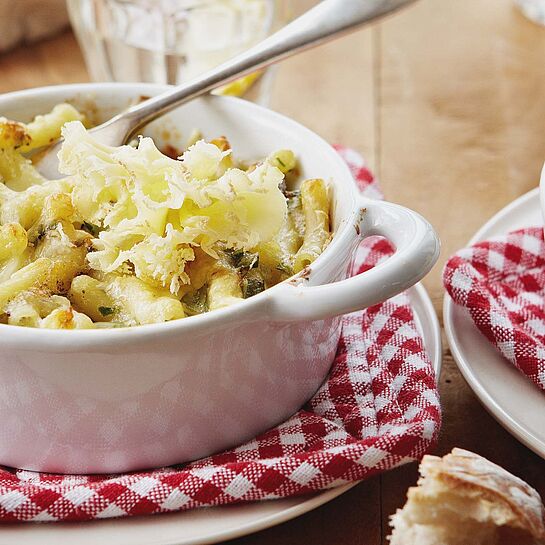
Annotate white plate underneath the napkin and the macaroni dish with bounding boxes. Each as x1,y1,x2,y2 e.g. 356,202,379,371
0,284,441,545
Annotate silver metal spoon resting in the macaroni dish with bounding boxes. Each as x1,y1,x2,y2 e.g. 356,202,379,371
37,0,414,179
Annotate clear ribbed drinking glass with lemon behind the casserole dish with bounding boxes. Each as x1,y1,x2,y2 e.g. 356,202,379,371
67,0,289,103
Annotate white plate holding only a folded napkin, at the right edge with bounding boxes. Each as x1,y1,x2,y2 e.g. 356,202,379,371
443,189,545,458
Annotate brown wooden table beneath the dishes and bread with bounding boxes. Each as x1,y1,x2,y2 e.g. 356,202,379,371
0,0,545,545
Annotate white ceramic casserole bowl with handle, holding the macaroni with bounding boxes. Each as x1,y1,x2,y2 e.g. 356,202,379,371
0,83,439,473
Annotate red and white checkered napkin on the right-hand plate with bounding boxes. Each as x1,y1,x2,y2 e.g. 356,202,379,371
443,227,545,390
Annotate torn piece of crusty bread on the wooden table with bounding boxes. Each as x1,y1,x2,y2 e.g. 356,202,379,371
390,448,545,545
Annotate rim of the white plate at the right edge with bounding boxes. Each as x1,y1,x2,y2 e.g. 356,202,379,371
443,187,545,458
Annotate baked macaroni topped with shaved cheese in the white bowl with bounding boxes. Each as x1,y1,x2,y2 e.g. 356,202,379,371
0,104,331,329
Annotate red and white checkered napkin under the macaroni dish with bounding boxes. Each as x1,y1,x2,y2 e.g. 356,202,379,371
0,149,441,522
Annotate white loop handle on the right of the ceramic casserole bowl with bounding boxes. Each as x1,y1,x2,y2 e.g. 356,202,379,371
269,197,440,321
